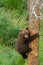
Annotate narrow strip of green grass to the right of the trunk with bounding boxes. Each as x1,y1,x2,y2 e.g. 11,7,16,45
39,21,43,65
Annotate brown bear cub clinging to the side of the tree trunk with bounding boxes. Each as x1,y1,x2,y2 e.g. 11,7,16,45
16,27,39,58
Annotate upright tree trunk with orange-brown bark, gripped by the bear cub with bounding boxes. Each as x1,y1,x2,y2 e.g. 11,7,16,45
27,0,40,65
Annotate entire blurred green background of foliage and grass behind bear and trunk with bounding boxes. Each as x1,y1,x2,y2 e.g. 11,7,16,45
0,0,43,65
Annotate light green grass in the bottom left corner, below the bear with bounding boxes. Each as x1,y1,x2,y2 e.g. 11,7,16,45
0,45,24,65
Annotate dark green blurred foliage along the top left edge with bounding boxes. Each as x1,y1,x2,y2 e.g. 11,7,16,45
0,0,27,14
